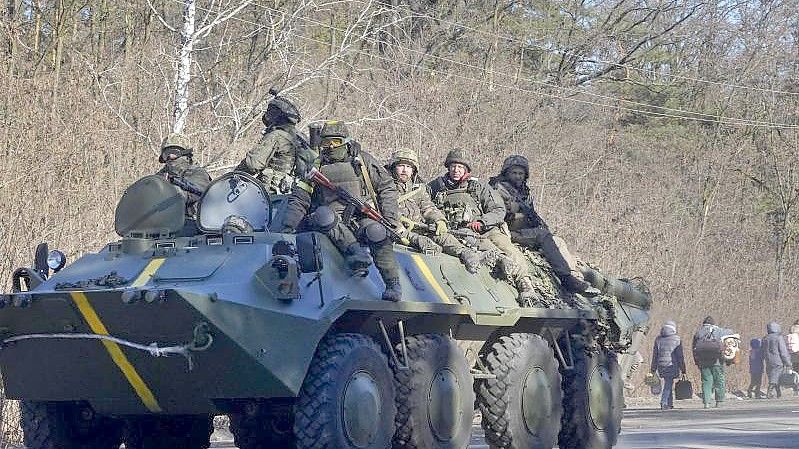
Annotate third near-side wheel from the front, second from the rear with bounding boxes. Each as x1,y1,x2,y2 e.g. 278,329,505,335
477,334,563,449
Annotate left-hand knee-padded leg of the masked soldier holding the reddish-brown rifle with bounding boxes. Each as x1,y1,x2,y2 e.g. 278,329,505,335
309,206,372,276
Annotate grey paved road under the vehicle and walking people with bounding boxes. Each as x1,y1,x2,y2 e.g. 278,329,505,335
212,398,799,449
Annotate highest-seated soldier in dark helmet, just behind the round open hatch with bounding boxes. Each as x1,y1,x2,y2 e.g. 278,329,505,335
235,90,315,193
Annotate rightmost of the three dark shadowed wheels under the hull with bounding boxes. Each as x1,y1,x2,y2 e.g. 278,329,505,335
229,404,294,449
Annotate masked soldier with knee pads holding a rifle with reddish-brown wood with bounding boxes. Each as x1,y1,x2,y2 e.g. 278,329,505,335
283,121,402,301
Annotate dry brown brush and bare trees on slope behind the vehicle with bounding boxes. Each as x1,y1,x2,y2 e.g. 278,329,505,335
0,0,799,430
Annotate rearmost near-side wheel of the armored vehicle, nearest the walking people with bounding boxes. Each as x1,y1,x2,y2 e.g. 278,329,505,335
558,344,624,449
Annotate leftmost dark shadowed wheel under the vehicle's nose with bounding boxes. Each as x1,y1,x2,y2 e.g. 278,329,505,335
20,401,123,449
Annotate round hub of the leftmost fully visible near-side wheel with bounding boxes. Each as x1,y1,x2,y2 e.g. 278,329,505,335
341,371,382,448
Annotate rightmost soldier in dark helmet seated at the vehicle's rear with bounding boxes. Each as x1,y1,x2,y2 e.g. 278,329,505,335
489,155,591,293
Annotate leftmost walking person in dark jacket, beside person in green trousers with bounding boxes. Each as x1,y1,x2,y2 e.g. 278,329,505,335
650,321,685,410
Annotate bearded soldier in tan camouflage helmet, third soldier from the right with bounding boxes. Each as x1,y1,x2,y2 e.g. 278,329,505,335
387,149,481,273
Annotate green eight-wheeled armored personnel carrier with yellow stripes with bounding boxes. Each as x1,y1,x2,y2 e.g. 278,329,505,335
0,174,649,449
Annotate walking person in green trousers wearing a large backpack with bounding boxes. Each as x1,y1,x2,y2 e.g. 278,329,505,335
691,316,726,408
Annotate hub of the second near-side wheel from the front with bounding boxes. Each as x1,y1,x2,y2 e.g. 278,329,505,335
427,369,463,442
